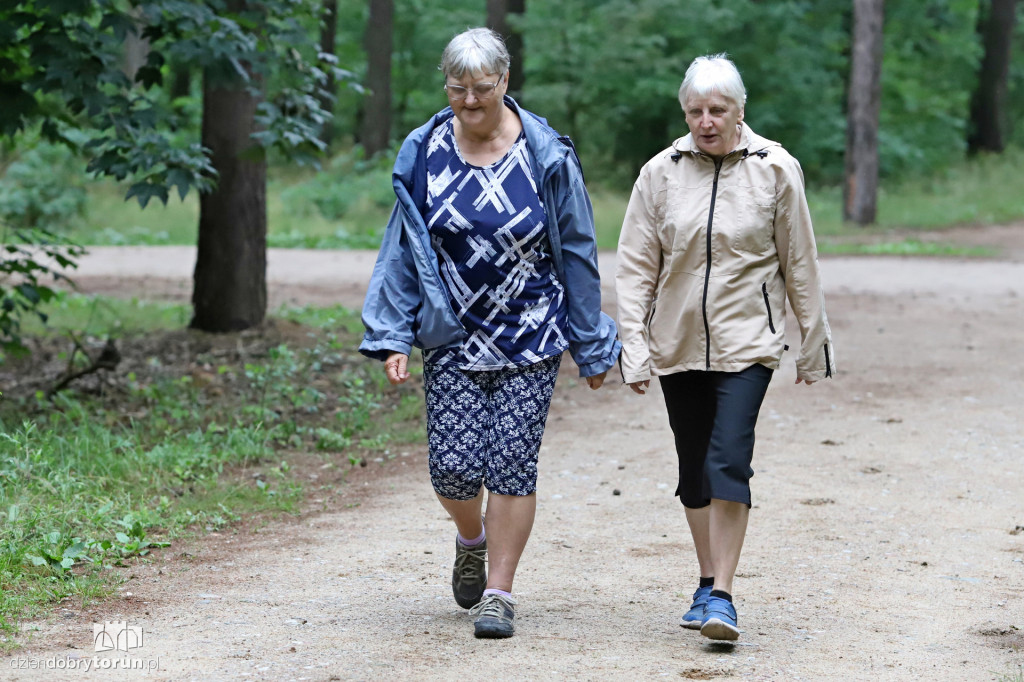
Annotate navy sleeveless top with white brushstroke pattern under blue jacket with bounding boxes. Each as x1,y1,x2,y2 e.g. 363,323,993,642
424,119,568,370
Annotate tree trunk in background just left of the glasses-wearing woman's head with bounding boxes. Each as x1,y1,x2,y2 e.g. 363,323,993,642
359,0,394,159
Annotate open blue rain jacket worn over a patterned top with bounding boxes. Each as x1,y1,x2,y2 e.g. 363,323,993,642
359,95,622,377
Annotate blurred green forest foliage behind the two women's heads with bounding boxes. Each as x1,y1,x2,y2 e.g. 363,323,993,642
321,0,1024,185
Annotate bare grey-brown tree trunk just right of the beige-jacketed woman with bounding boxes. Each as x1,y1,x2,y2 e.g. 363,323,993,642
843,0,885,225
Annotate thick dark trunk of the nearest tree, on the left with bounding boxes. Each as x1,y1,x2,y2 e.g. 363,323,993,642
191,67,266,332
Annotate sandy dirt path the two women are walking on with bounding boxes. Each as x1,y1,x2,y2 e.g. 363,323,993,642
0,228,1024,681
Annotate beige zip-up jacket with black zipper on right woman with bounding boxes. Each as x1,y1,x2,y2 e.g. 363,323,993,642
615,124,836,383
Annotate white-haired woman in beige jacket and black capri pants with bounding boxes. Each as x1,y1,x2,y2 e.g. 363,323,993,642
615,54,836,640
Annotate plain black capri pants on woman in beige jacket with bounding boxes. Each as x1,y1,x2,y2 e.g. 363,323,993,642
658,365,772,509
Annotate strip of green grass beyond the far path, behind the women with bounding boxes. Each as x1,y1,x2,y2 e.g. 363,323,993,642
64,148,1024,255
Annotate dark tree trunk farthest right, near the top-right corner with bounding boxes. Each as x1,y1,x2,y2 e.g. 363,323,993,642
967,0,1017,154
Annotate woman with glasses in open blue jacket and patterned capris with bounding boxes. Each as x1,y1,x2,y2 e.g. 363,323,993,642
359,29,621,637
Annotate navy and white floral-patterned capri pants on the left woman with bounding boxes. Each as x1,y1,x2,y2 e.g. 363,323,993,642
423,355,561,500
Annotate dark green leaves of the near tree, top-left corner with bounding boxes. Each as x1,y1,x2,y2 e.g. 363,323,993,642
0,0,350,206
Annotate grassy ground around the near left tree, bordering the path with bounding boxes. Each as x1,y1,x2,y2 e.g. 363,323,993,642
0,294,423,649
